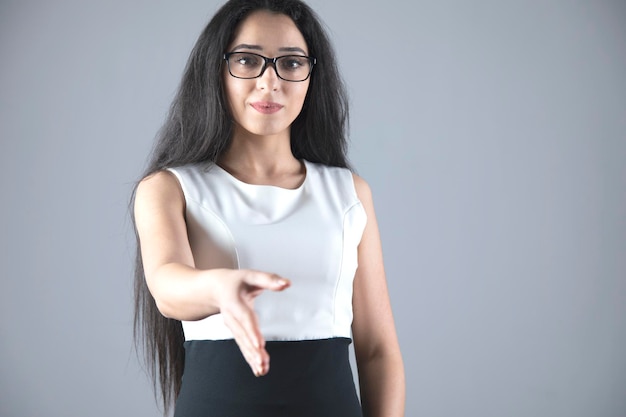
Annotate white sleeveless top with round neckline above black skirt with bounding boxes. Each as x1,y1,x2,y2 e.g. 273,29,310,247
170,161,367,341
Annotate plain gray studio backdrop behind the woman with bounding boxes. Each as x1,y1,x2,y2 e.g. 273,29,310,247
0,0,626,417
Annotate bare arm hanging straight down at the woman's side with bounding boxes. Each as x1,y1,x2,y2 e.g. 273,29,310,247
352,176,405,417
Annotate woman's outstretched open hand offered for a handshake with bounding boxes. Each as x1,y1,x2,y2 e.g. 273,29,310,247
215,270,291,376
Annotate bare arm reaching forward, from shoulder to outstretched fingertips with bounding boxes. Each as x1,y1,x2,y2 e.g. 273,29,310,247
134,172,289,375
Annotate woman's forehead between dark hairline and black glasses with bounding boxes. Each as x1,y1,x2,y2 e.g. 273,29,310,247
229,10,307,52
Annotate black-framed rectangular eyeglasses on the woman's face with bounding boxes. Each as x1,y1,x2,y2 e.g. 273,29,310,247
224,52,317,82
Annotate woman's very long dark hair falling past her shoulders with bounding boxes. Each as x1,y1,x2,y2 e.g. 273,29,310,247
131,0,349,414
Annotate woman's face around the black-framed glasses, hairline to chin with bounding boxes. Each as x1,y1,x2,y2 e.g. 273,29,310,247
223,11,309,136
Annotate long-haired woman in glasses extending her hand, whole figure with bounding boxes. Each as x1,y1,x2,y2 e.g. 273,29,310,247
134,0,404,417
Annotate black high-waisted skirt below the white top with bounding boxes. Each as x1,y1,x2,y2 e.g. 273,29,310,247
174,338,362,417
